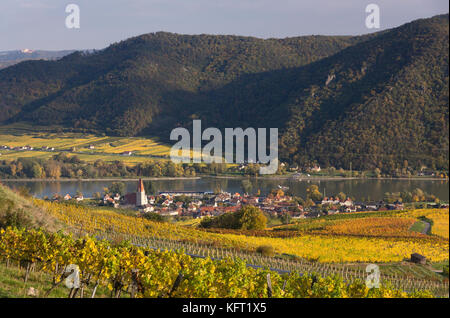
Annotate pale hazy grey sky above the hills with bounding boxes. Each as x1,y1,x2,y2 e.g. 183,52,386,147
0,0,449,51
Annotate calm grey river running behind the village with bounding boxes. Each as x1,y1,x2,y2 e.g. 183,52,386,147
2,177,449,201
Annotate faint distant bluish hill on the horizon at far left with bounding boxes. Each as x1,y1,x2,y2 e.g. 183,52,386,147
0,49,74,69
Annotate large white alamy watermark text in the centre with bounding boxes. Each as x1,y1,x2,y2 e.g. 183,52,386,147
170,120,278,174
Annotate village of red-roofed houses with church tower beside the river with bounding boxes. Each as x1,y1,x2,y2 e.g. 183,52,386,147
47,179,448,219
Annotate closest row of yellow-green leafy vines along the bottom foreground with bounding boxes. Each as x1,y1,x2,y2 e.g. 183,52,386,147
0,228,438,298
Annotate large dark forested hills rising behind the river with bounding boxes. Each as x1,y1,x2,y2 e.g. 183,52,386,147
0,14,449,171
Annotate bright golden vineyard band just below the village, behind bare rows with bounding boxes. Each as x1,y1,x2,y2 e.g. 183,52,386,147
36,200,449,263
